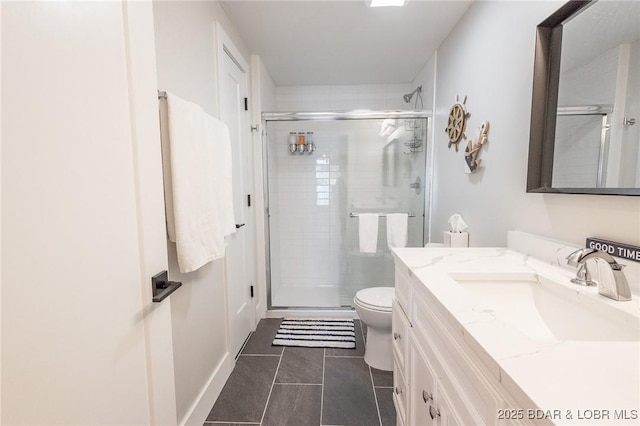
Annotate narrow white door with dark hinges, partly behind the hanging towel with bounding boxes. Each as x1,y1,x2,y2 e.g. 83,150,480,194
218,26,252,356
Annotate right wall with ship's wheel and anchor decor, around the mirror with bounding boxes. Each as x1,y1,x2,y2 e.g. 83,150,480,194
432,1,640,290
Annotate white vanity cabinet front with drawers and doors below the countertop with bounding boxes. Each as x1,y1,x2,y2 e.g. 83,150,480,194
392,265,524,426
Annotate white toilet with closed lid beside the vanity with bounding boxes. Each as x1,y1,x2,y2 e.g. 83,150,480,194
353,287,395,371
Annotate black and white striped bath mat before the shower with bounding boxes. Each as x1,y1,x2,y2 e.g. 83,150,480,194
272,318,356,349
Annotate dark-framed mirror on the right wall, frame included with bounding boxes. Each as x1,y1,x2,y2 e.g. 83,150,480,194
527,0,640,195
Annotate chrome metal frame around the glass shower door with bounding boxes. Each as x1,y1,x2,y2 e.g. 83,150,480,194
261,110,433,312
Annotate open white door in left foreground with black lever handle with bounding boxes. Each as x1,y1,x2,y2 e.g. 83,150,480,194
1,2,176,425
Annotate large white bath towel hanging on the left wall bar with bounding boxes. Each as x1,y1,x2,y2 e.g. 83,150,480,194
161,93,235,272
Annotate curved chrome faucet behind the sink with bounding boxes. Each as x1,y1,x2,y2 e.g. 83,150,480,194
567,248,631,301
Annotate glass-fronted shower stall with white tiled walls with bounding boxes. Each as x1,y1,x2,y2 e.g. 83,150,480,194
263,111,429,309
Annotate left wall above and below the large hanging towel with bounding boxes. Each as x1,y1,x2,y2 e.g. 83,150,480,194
153,1,248,422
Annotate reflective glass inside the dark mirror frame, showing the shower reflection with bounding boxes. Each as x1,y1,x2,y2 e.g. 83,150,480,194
553,1,640,188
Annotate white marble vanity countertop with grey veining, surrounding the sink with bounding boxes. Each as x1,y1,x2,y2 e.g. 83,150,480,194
393,248,640,425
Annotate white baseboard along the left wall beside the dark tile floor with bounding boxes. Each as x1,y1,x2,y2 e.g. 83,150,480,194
179,352,233,426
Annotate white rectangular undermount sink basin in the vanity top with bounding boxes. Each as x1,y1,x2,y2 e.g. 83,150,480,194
454,274,640,341
